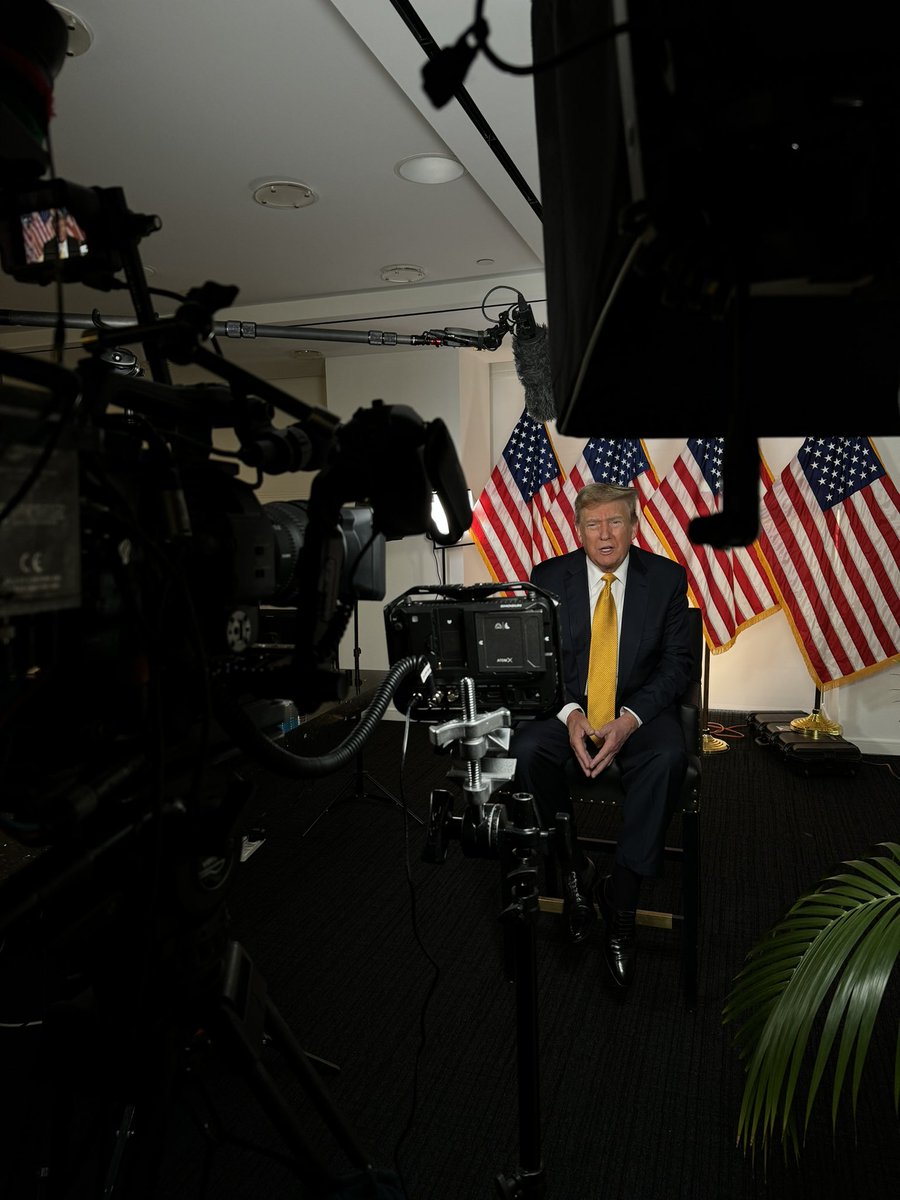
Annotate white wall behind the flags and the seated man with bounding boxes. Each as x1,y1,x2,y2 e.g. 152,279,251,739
256,348,900,754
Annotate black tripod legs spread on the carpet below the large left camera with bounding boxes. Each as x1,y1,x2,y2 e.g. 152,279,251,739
28,941,401,1200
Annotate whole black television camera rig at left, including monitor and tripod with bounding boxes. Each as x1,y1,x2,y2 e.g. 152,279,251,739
0,4,470,1198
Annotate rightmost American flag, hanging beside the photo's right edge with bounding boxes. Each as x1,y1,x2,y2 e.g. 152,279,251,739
760,437,900,689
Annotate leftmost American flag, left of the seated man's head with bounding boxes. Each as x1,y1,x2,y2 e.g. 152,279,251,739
472,410,562,582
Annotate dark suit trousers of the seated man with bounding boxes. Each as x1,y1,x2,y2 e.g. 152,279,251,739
510,710,688,876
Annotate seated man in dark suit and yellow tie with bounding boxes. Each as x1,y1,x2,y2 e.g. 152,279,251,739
510,484,691,988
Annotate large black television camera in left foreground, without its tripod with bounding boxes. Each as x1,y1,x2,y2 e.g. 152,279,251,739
0,229,469,840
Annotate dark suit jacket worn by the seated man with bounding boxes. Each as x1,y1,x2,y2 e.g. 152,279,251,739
530,546,691,721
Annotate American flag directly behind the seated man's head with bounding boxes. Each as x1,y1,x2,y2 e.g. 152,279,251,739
547,438,666,554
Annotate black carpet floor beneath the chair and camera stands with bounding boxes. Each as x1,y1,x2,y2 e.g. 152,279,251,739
0,713,900,1200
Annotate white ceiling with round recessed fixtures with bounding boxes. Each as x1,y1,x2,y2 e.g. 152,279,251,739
0,0,544,378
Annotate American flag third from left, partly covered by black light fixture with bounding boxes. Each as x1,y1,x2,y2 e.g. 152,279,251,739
644,438,779,654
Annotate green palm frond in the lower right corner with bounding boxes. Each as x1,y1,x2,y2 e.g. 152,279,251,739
722,842,900,1154
